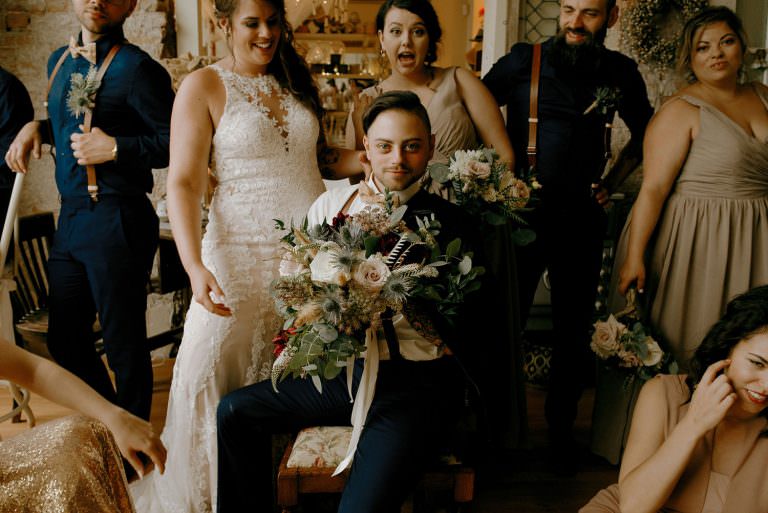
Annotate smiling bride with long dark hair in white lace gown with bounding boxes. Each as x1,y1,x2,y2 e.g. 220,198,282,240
131,0,359,513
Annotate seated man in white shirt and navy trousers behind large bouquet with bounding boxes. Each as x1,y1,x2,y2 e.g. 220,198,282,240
218,91,480,513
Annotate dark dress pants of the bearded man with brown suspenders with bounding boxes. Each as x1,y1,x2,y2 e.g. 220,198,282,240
517,198,607,440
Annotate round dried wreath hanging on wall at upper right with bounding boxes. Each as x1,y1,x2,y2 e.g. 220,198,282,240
621,0,709,70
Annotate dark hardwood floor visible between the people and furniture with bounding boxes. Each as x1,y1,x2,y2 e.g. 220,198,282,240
0,360,618,513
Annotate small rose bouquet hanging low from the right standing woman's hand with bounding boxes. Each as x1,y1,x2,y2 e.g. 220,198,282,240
589,289,678,384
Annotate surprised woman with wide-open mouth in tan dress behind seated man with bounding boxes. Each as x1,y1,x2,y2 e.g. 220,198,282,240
346,0,527,447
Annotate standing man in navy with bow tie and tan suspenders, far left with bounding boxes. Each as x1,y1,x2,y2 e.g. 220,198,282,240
6,0,173,419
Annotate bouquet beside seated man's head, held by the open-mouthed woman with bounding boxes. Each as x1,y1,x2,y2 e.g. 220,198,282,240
429,148,541,245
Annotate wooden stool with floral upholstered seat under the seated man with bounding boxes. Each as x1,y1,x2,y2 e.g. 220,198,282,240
277,426,475,513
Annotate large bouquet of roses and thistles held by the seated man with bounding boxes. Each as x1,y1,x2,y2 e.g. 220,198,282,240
272,194,484,391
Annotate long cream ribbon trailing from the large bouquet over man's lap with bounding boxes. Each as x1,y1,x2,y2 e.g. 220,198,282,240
333,328,379,476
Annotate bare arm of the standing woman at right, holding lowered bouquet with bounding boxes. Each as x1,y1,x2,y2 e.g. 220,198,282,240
619,100,699,294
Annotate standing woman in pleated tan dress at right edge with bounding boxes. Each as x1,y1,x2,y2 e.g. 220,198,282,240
616,7,768,368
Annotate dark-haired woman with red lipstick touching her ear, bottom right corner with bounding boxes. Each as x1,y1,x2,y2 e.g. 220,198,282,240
579,286,768,513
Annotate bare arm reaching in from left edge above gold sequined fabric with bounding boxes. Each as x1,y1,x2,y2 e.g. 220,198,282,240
0,340,166,477
